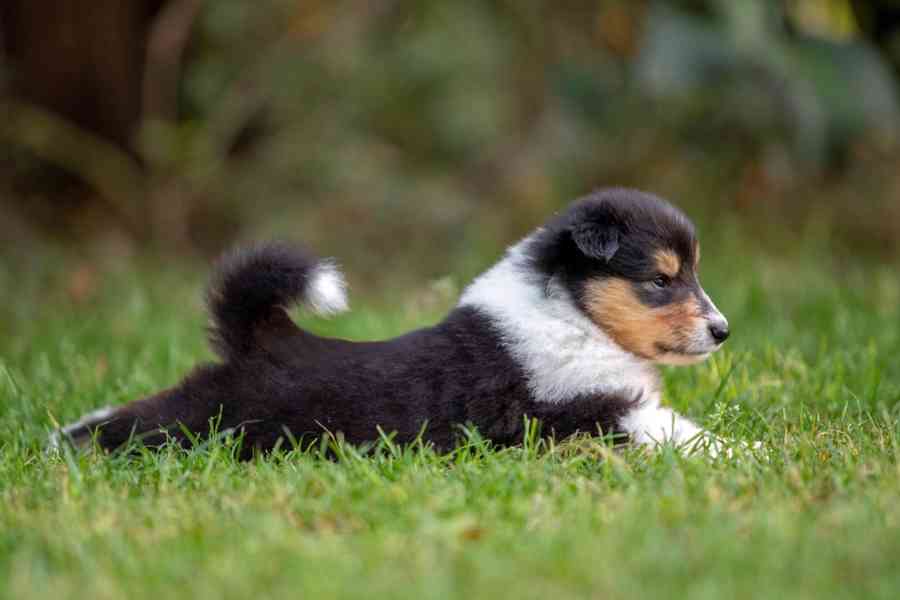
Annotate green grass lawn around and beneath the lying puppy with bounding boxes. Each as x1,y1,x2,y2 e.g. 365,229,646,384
0,242,900,600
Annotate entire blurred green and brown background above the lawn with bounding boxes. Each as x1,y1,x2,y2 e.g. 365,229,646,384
0,0,900,296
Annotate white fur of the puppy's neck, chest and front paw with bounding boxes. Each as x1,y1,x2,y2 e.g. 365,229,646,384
459,239,715,454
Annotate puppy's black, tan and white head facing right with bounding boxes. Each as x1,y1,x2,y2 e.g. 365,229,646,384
532,189,729,364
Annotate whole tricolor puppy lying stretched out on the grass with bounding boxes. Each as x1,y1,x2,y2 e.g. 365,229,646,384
57,189,728,455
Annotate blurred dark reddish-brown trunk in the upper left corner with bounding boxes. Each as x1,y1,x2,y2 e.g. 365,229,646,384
0,0,165,151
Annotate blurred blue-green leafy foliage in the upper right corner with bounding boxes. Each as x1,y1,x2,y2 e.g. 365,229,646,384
636,2,900,168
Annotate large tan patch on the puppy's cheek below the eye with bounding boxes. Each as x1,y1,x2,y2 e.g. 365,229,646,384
585,278,703,360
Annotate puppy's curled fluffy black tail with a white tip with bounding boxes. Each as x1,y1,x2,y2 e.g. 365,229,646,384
207,242,347,360
